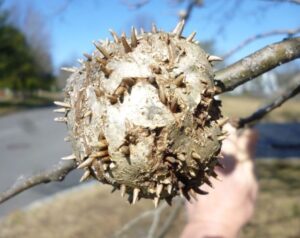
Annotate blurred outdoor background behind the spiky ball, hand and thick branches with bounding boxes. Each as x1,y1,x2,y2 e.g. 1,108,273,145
0,0,300,237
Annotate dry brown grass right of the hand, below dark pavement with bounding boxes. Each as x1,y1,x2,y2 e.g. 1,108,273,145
242,160,300,238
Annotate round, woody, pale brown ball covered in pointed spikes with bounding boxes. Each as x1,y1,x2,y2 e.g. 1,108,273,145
54,21,227,207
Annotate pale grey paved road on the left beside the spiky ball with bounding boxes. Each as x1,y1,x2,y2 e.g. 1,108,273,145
0,108,80,217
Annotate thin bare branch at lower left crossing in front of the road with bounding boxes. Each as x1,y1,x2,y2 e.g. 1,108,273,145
0,160,76,204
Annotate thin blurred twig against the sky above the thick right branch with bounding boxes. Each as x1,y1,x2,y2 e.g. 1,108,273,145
222,27,300,59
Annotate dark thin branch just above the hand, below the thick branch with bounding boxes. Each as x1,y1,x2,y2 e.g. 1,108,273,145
233,74,300,128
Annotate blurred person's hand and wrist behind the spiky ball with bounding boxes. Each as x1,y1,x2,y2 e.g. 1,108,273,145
181,124,258,238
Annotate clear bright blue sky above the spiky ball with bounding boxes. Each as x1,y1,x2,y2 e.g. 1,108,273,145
5,0,300,71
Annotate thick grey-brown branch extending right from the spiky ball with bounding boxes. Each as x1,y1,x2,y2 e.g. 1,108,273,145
215,37,300,94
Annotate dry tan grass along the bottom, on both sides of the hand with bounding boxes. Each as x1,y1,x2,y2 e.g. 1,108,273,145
0,160,300,238
